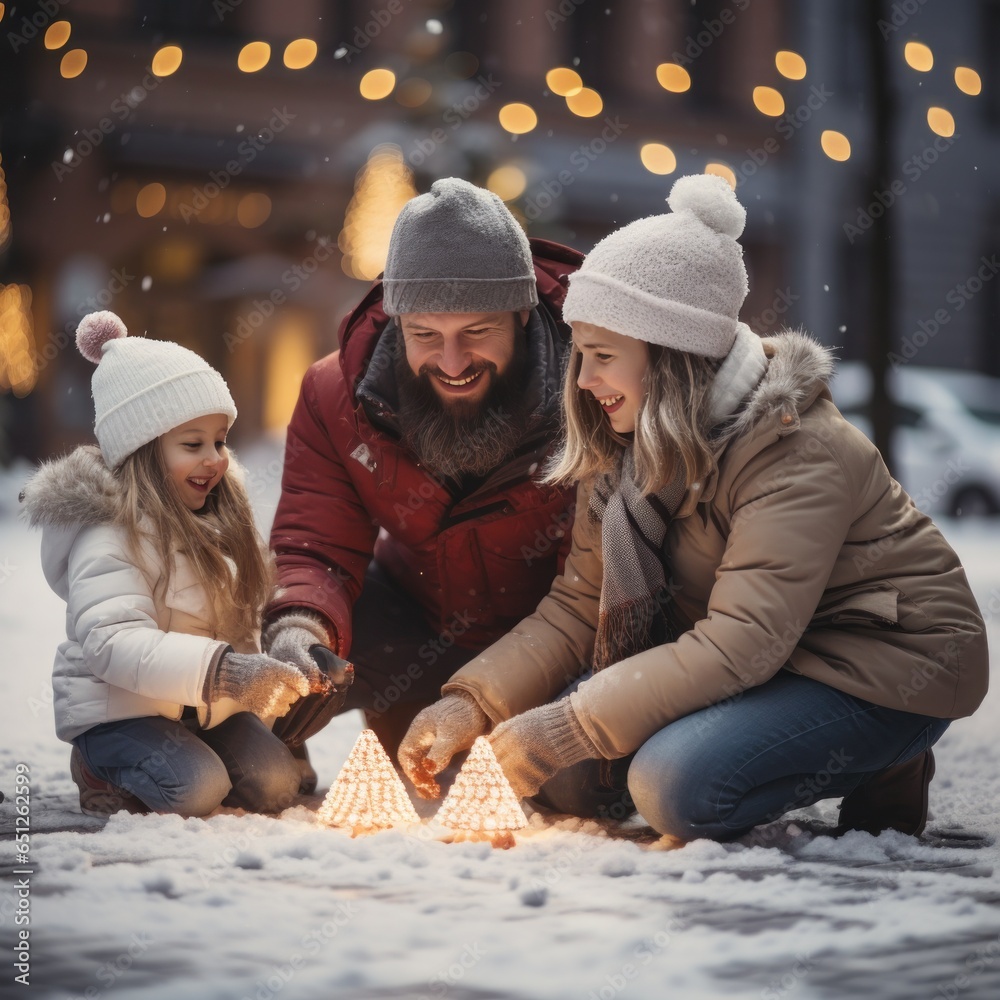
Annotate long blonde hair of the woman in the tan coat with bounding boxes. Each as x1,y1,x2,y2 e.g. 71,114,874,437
544,344,721,493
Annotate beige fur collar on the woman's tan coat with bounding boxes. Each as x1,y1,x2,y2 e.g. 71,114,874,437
716,330,834,443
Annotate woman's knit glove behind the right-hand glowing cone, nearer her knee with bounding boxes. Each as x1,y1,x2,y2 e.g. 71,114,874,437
490,698,601,798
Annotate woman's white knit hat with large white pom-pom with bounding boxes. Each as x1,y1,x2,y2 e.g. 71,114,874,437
563,174,747,358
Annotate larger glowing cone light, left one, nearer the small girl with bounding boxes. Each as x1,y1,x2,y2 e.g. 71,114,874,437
317,729,420,837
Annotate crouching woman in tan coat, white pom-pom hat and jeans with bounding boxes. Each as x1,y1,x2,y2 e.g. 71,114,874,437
400,175,988,841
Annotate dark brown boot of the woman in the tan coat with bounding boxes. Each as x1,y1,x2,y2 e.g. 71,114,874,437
834,750,934,837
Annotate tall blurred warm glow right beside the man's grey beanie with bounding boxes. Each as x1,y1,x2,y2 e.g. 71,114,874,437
337,145,417,281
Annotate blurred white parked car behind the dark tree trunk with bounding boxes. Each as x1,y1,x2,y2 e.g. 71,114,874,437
831,362,1000,517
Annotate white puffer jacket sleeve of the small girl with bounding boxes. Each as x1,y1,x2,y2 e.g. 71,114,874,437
67,525,227,706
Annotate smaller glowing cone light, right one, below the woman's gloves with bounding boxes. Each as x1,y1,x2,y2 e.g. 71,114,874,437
435,736,528,847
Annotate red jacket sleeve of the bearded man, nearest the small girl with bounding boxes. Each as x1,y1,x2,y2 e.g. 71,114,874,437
265,355,378,656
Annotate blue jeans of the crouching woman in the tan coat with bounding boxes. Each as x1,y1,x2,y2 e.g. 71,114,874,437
539,670,949,841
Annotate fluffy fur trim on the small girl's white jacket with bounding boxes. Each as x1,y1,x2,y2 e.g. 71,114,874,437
19,445,120,528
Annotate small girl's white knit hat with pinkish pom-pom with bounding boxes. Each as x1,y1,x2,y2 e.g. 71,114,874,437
76,310,236,469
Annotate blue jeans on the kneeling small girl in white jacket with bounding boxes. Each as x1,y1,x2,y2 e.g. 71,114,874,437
73,712,299,816
